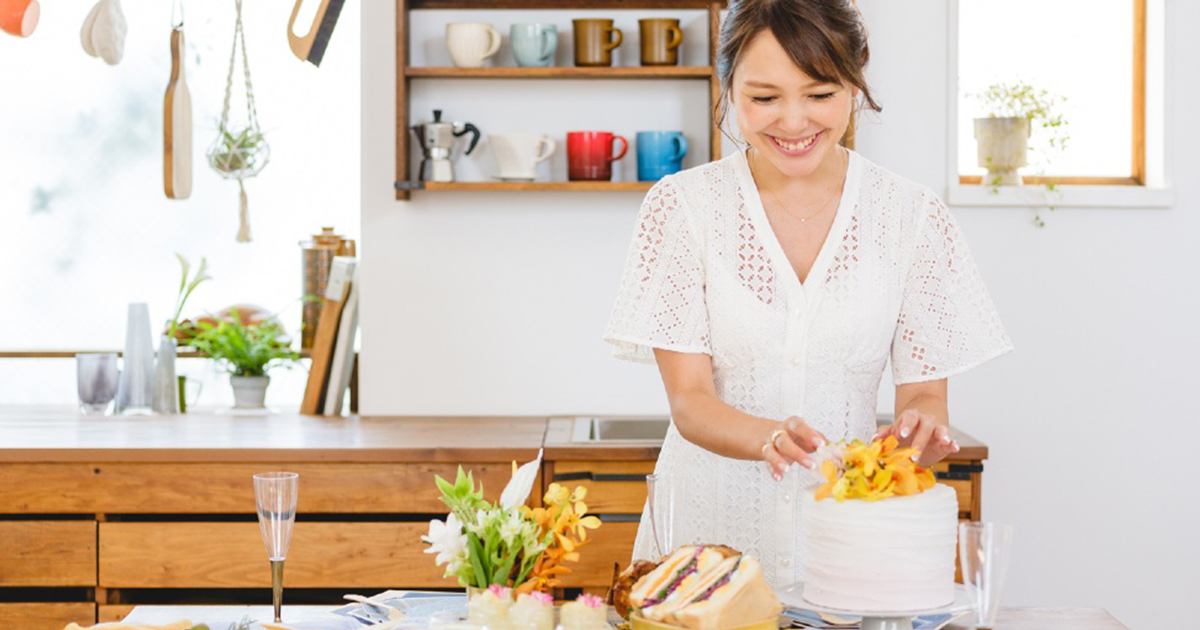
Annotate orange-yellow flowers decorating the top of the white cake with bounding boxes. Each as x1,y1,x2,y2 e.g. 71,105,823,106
814,436,936,502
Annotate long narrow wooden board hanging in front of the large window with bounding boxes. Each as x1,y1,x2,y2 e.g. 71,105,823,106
162,26,192,199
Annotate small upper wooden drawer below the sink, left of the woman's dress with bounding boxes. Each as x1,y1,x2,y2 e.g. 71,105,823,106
548,462,654,513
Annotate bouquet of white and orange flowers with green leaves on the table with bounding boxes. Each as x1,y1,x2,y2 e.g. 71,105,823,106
421,454,600,593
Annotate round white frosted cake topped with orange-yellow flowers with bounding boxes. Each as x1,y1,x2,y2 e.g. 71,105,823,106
800,437,959,612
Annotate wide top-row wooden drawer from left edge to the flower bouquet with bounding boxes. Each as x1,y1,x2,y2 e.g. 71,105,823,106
0,462,512,514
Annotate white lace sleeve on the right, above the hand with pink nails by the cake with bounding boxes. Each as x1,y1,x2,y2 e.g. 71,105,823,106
892,192,1013,385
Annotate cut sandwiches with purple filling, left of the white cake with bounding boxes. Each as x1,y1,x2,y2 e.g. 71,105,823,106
629,547,784,630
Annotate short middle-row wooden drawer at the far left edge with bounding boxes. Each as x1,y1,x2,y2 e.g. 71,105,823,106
0,521,96,585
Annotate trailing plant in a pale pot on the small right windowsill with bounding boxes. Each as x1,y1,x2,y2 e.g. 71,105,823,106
973,82,1069,190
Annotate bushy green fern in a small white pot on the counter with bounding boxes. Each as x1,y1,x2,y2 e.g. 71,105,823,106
191,310,300,409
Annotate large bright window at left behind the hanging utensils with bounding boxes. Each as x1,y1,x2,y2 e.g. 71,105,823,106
0,2,360,404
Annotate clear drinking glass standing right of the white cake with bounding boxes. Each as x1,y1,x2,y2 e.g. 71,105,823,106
959,522,1013,630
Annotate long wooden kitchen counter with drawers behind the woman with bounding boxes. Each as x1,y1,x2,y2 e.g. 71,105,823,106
0,408,988,630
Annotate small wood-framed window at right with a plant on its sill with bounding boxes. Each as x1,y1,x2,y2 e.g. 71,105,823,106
952,0,1153,186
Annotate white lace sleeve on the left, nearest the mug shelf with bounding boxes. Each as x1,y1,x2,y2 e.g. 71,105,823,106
604,178,712,362
